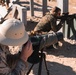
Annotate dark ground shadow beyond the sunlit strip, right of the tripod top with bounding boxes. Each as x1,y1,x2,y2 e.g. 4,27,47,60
45,41,76,58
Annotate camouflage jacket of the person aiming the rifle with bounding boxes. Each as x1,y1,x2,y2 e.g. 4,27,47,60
34,14,62,32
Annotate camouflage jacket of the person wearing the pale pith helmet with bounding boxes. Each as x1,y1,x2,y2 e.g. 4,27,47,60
0,47,26,75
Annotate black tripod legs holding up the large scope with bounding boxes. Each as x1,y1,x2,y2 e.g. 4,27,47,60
26,49,49,75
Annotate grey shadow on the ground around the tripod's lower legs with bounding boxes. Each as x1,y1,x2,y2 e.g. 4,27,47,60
29,61,76,75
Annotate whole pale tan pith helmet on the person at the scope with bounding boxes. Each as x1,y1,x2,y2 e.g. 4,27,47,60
0,18,29,46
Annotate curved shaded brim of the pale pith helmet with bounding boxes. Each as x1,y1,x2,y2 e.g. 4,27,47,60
0,31,29,46
